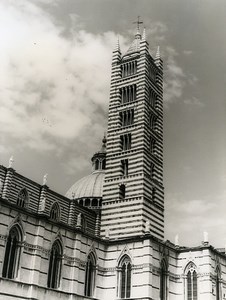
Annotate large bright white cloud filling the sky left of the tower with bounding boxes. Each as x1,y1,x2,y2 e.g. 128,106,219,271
0,1,125,172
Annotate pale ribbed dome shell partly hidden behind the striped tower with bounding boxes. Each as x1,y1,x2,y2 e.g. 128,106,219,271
66,170,105,199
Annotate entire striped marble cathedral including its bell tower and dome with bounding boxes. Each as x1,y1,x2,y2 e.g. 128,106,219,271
0,21,226,300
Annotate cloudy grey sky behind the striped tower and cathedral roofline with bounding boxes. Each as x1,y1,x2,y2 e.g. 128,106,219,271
0,0,226,247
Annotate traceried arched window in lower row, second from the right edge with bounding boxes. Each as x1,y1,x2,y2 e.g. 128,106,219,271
186,263,198,300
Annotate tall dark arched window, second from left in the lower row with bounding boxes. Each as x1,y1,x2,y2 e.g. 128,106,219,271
47,240,63,289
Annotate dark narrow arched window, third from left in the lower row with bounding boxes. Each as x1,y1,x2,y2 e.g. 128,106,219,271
84,253,96,297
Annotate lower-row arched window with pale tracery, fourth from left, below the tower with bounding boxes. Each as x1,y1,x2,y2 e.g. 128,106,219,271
118,255,132,298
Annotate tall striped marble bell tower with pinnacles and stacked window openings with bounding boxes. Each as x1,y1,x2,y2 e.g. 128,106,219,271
101,19,164,239
